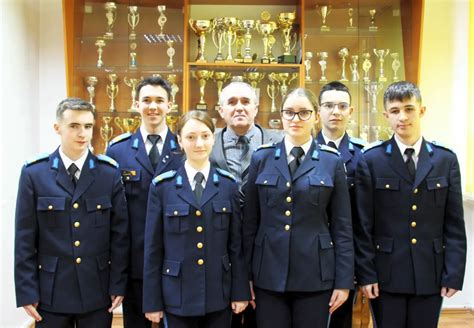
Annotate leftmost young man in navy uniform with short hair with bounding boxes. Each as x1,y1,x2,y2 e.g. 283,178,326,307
15,98,129,328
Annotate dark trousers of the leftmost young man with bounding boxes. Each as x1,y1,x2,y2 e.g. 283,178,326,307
35,309,112,328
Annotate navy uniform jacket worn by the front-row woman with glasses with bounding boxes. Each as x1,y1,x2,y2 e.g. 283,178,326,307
243,141,354,292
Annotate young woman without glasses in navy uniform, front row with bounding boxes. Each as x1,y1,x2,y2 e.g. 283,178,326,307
143,111,250,328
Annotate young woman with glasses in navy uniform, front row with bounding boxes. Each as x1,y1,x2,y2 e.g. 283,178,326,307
243,88,354,328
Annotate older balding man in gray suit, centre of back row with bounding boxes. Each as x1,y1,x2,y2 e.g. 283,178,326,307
210,82,282,328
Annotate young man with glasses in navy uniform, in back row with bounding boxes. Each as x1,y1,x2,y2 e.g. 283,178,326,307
317,81,366,328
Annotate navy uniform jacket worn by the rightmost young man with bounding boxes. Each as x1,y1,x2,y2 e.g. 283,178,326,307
354,137,466,295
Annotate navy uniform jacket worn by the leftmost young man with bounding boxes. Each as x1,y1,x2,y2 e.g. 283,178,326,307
15,150,129,313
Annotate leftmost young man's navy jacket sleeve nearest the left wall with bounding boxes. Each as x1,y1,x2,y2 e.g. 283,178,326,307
15,167,40,307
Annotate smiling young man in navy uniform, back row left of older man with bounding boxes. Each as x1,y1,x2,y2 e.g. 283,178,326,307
107,77,182,328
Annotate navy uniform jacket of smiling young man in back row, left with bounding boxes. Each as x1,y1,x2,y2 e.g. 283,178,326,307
107,130,182,279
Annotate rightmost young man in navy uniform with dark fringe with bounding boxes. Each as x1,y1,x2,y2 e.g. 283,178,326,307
354,81,466,328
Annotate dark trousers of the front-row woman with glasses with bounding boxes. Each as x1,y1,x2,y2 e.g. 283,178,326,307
254,287,332,328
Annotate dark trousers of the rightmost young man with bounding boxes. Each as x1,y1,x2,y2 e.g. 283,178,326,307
370,292,443,328
